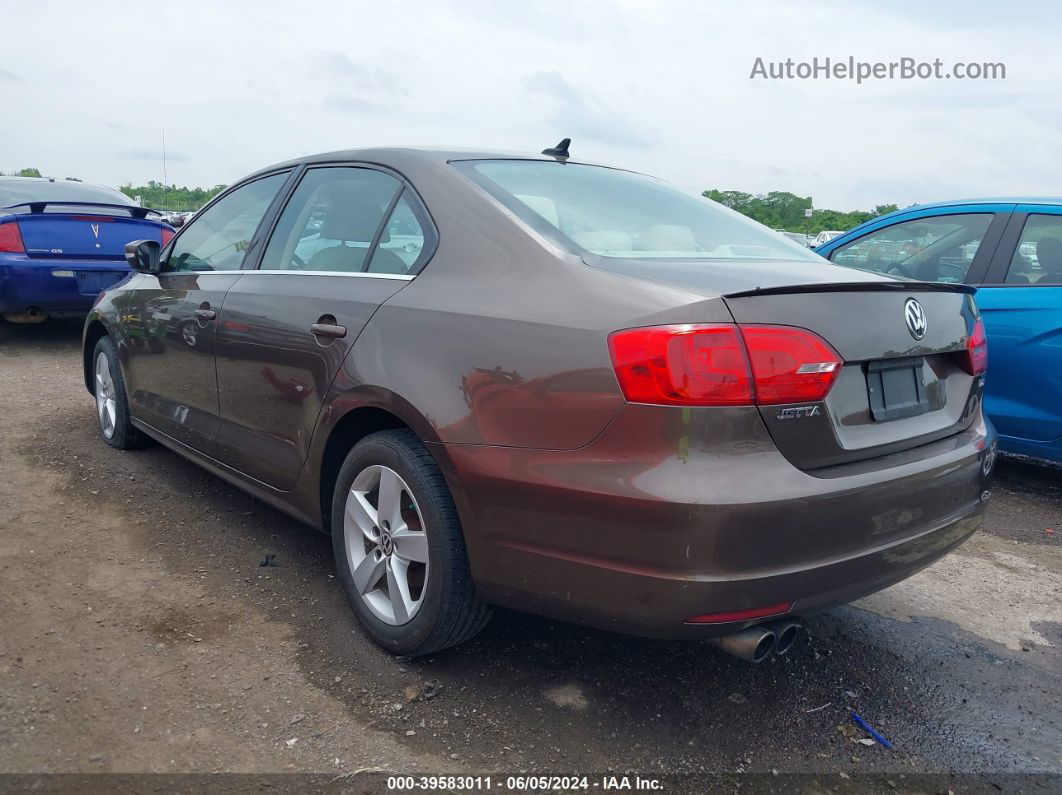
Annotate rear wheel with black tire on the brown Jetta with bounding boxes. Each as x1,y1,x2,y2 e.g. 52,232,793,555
331,430,491,657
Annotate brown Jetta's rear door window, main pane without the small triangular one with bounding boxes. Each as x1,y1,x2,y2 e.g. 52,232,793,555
261,167,405,273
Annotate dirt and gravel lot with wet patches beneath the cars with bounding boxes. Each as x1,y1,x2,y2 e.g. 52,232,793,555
0,325,1062,775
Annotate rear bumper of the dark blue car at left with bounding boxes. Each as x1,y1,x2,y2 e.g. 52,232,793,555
0,254,132,315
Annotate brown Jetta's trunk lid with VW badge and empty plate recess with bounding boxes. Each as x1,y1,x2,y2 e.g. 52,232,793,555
723,281,983,470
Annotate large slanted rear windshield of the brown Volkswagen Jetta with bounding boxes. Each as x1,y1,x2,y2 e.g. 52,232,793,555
453,160,820,261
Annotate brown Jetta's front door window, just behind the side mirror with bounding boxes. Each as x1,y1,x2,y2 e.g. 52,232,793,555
166,173,288,272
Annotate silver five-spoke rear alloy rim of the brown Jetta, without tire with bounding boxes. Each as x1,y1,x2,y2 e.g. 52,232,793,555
343,465,429,626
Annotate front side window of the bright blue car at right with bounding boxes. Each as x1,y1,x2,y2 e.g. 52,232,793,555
829,212,992,283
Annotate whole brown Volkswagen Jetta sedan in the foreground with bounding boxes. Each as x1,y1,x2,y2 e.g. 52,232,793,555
84,149,995,659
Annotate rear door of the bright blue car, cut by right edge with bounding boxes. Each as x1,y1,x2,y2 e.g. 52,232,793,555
977,205,1062,457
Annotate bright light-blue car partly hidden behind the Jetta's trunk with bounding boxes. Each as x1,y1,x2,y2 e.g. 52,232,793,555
816,198,1062,462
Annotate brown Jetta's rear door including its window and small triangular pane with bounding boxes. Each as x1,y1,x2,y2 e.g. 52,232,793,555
217,165,434,489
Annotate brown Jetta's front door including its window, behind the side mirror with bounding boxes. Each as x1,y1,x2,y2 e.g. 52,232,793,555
125,171,291,455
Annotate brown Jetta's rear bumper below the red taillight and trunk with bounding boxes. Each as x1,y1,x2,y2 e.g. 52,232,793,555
432,405,995,638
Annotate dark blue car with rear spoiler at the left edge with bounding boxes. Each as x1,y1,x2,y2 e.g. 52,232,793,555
0,176,173,323
